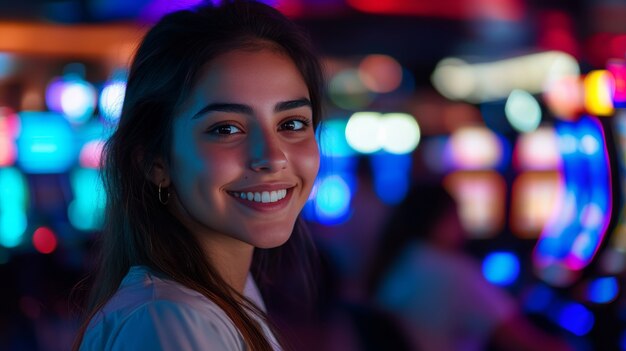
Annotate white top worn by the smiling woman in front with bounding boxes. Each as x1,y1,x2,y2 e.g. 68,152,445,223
80,266,280,351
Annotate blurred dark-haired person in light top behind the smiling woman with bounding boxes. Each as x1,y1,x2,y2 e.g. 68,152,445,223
366,182,572,351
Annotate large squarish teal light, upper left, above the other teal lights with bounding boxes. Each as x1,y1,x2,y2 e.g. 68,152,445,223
17,112,77,173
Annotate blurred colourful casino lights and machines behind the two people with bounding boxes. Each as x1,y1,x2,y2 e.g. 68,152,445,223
0,0,626,350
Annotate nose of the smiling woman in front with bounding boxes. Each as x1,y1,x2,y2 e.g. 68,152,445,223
250,132,287,173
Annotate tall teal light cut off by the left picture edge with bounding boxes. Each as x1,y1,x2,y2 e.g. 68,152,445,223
0,168,28,248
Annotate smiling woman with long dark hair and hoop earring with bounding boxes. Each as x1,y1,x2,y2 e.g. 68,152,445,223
75,1,322,350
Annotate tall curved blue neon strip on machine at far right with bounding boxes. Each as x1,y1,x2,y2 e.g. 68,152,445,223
533,117,612,285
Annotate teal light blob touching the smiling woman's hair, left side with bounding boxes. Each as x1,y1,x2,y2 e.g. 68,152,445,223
67,168,106,231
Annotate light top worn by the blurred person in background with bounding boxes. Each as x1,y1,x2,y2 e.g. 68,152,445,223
377,243,517,351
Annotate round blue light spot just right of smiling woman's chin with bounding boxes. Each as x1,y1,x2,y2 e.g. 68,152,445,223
315,175,352,224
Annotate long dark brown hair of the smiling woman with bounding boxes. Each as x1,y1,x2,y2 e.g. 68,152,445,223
74,1,323,350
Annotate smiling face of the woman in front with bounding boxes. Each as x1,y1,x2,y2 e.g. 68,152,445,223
169,49,319,252
